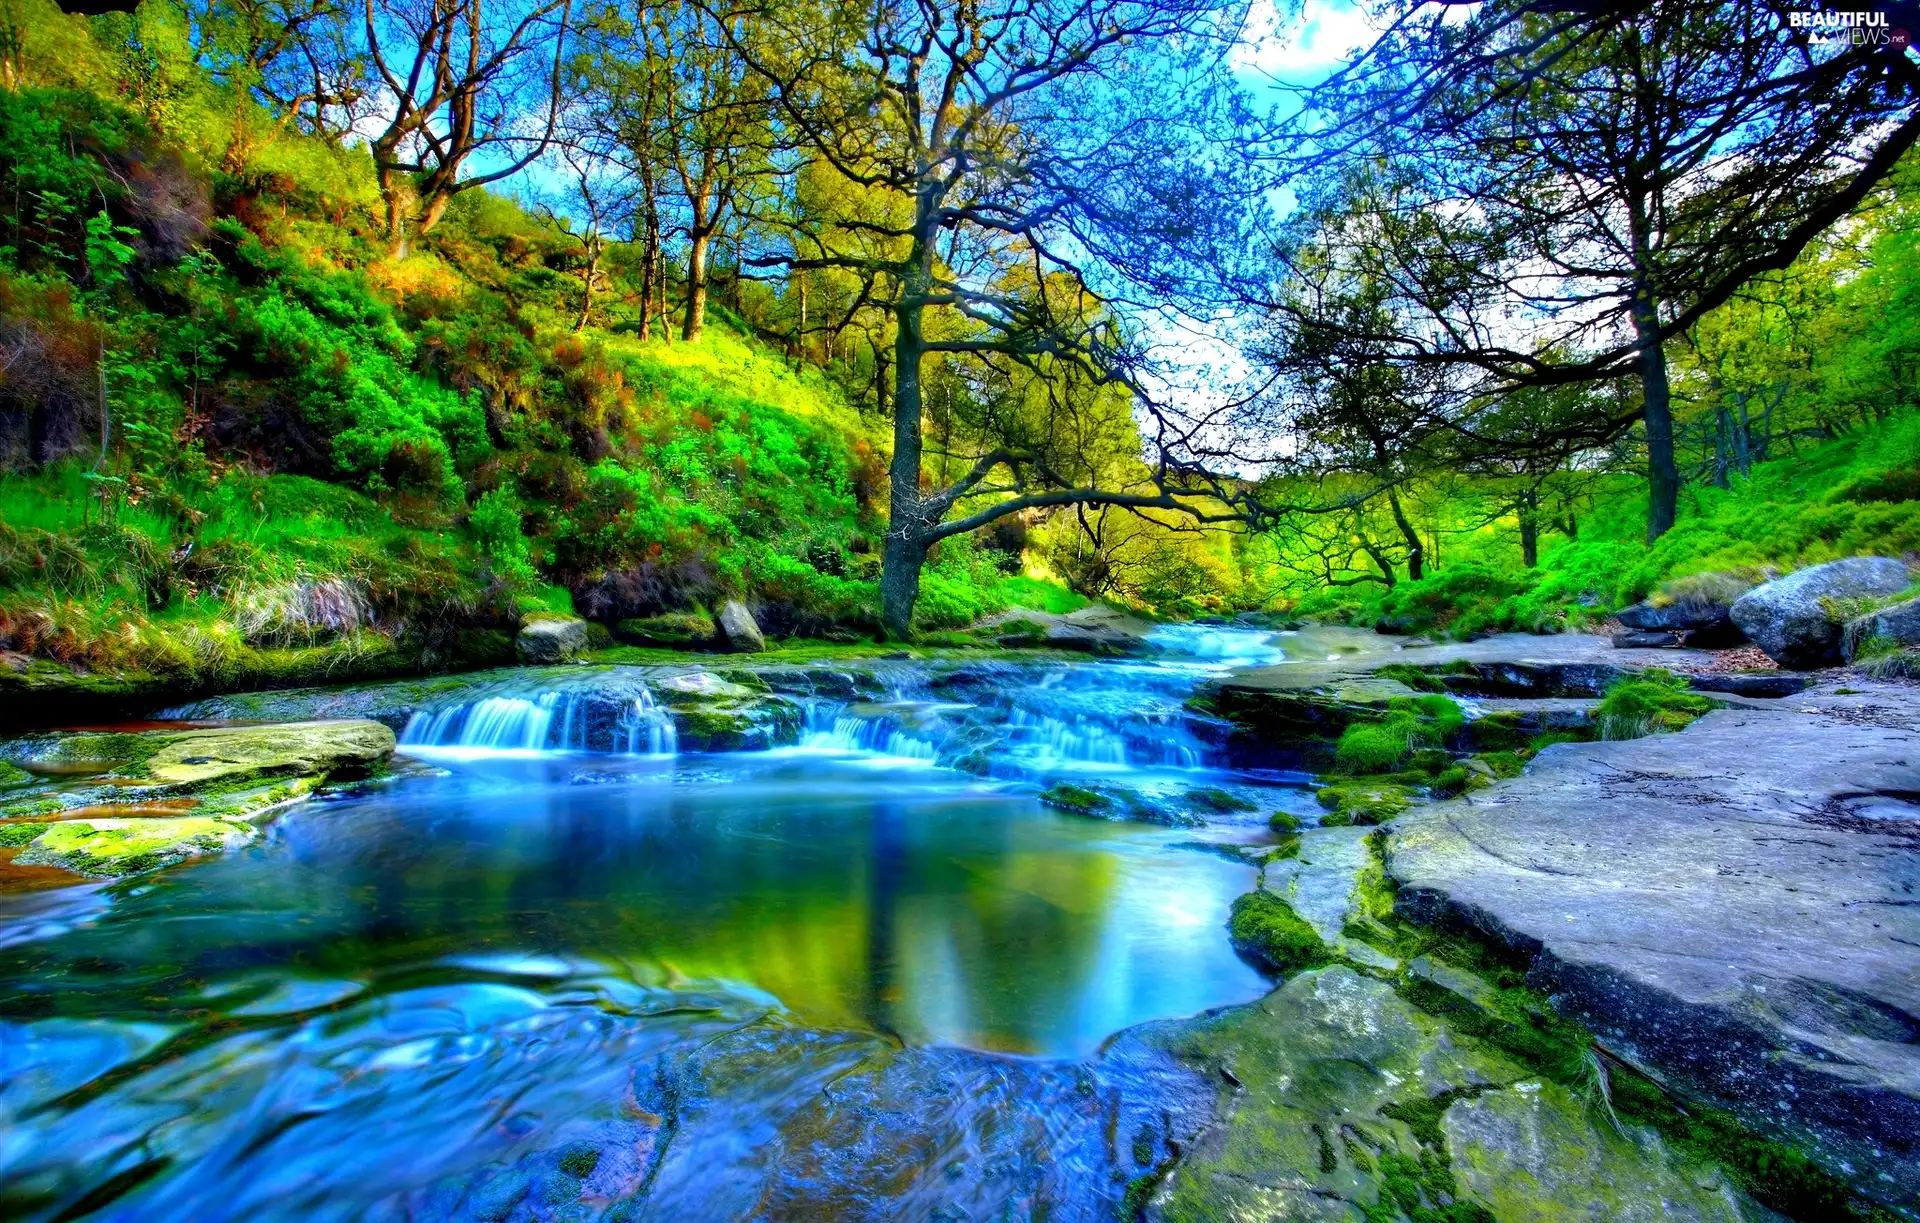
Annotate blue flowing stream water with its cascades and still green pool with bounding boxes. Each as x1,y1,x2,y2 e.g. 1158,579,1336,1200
0,628,1302,1219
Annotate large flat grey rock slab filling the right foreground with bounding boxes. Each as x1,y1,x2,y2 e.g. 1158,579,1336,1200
1388,682,1920,1211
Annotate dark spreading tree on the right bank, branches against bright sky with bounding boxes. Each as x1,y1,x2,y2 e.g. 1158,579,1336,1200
1296,0,1920,540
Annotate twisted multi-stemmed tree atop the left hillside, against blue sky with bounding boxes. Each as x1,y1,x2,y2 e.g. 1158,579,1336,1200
363,0,572,255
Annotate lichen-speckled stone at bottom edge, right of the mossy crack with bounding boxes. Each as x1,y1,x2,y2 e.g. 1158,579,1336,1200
1440,1081,1743,1223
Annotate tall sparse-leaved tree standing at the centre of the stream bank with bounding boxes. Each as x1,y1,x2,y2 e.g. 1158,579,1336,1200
701,0,1244,635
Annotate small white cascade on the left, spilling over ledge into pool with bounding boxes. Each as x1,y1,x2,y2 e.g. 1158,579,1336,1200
399,687,680,756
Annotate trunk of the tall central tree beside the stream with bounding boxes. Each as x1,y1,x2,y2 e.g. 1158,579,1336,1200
879,238,933,641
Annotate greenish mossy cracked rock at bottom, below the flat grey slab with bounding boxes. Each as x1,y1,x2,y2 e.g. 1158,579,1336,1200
1144,966,1741,1223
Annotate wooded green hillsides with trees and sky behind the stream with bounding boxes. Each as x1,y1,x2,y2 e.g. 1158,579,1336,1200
0,0,1920,687
